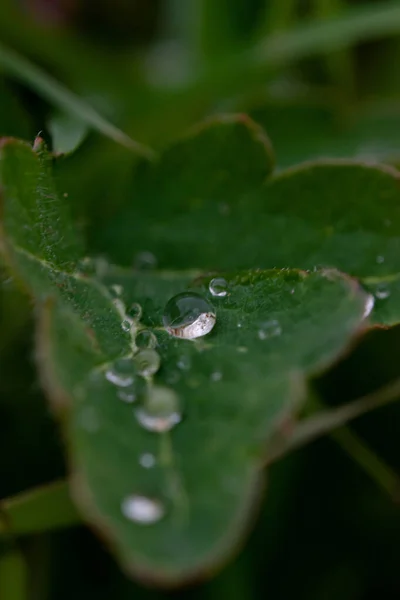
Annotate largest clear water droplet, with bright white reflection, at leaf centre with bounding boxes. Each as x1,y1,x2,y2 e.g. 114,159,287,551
163,292,216,340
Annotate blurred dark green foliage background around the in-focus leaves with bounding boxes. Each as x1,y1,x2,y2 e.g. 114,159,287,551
0,0,400,600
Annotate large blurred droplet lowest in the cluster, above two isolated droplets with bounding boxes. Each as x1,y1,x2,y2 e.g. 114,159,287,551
135,385,182,433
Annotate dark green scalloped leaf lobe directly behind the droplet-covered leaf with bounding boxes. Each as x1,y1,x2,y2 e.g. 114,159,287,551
95,118,400,324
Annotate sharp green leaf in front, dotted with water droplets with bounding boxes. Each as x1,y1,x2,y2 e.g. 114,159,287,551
0,135,370,582
